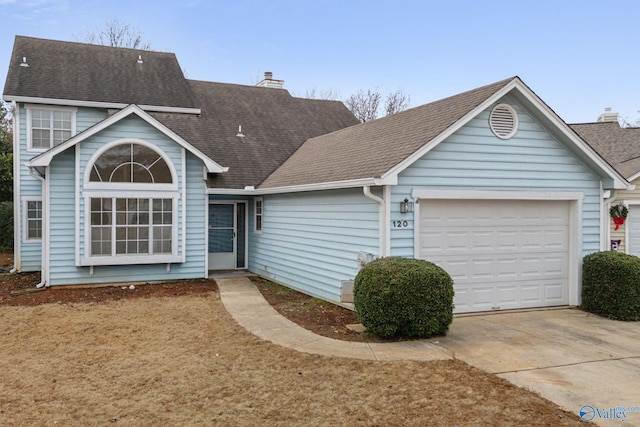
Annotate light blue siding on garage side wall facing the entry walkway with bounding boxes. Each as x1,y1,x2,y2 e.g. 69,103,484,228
249,189,379,302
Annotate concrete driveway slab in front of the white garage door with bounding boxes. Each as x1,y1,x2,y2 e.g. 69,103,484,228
438,309,640,426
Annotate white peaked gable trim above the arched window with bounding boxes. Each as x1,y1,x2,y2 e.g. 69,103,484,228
27,104,229,173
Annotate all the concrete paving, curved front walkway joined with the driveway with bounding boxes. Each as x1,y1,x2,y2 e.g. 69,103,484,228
216,277,640,426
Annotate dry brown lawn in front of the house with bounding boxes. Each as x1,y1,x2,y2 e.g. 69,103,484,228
0,287,580,426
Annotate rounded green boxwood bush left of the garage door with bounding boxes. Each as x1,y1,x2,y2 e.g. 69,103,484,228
353,257,453,338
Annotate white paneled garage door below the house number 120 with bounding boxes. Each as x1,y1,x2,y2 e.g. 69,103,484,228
419,199,569,313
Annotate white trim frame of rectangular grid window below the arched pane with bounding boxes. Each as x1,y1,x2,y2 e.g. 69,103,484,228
80,191,183,266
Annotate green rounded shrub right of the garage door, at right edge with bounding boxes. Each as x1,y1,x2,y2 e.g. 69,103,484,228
582,251,640,320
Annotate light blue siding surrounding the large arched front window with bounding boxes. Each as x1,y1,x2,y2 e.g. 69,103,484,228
49,117,207,285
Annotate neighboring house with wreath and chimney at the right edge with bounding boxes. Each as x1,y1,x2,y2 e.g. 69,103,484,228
570,109,640,256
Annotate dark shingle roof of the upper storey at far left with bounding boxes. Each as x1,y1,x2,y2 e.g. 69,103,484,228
3,36,197,108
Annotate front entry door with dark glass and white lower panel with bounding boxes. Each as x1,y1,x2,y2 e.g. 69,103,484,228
209,203,237,270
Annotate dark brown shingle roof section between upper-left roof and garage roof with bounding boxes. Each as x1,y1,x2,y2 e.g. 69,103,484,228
152,81,358,188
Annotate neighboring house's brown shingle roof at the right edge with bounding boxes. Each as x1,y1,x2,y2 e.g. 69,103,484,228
569,122,640,178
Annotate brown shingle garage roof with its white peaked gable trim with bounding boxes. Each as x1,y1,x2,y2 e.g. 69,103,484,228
260,77,627,189
